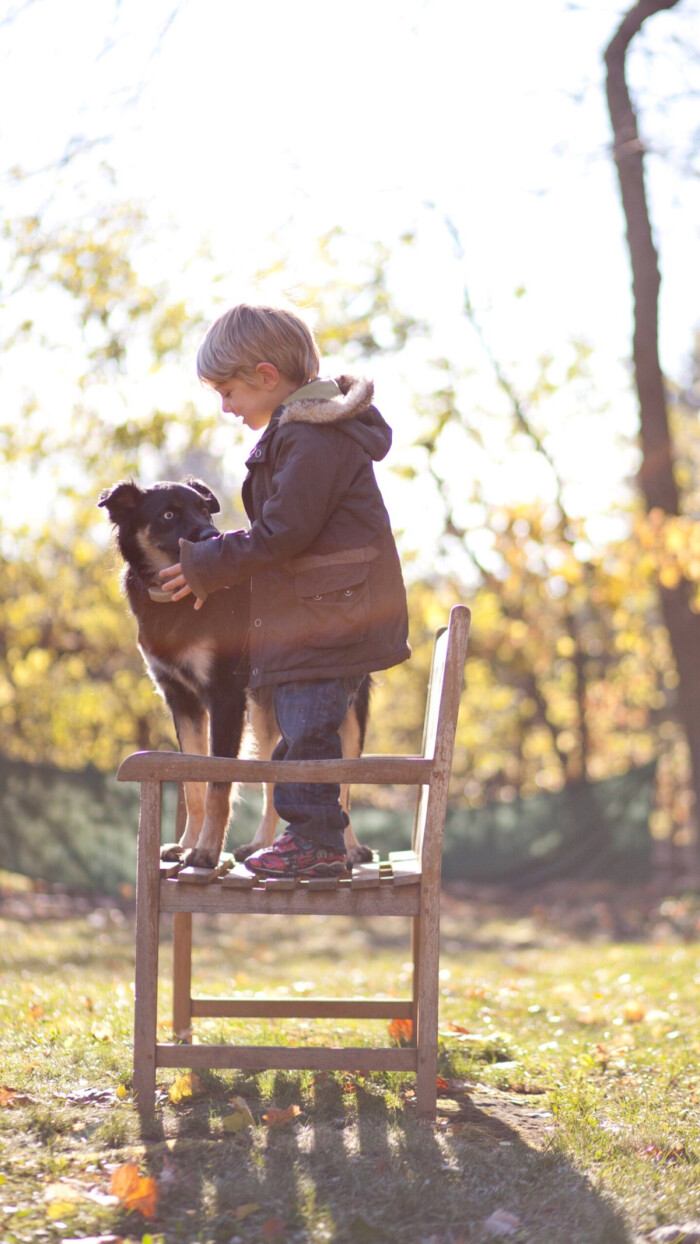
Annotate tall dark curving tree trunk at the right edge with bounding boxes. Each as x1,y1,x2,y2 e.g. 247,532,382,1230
606,0,700,875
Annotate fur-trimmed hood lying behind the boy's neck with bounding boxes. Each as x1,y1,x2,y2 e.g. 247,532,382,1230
274,376,392,462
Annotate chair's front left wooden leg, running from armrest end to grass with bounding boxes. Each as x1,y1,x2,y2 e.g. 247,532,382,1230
133,781,162,1116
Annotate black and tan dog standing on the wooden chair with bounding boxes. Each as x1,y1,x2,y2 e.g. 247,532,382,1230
98,476,372,868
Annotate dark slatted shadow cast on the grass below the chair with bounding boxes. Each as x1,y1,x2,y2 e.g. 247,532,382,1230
134,1072,632,1244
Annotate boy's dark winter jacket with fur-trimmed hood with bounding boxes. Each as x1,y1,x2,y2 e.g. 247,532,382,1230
182,376,410,687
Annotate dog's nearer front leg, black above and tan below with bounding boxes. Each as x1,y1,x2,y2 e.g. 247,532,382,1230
184,667,245,868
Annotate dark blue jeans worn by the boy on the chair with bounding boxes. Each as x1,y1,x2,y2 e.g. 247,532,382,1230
272,678,362,851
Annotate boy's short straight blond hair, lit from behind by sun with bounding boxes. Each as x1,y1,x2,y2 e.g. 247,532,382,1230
196,302,321,387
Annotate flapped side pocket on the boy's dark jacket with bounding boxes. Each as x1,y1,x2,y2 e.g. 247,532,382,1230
295,561,372,648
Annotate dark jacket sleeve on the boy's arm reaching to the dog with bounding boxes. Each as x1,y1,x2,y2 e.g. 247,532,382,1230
180,424,352,600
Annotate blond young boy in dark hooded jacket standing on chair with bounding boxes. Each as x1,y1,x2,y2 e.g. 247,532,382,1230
162,305,410,877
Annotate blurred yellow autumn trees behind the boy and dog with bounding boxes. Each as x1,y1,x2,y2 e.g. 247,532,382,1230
0,5,700,865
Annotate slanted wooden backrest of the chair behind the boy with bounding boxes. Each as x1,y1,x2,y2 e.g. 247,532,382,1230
413,605,470,870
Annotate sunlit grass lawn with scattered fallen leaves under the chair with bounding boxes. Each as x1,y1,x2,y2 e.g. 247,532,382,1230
0,878,700,1244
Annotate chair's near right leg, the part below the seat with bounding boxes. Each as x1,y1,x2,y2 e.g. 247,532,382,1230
414,902,440,1120
